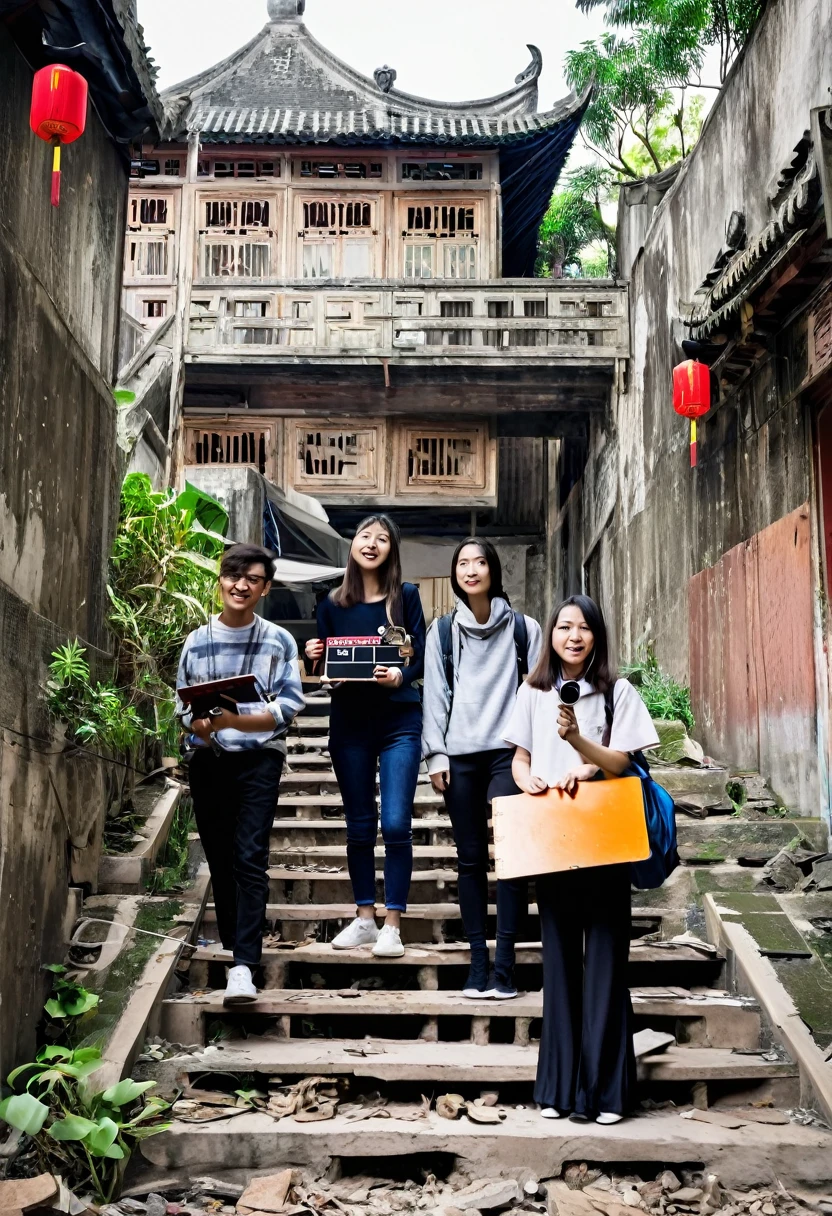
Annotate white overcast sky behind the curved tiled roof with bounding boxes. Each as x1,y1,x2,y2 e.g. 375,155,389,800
139,0,603,102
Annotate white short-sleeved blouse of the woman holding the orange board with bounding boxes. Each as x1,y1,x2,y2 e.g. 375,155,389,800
506,680,659,787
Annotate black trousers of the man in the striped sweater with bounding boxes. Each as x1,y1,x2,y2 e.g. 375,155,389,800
190,748,283,967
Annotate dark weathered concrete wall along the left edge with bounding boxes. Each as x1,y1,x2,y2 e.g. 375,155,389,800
0,26,127,1076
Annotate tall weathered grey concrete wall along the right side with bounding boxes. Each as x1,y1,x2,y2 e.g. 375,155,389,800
562,0,832,814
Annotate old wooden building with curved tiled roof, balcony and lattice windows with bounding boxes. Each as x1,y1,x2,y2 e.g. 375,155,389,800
124,0,628,610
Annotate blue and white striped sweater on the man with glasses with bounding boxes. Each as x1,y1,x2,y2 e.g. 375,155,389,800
176,617,304,754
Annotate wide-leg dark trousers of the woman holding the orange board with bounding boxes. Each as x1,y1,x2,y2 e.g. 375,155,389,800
534,866,636,1119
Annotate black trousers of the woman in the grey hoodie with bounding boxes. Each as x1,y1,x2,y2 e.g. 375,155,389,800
445,748,529,978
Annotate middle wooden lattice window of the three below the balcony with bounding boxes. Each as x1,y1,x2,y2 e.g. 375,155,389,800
289,420,380,494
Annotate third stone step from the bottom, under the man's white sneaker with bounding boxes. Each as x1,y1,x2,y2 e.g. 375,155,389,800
161,987,760,1049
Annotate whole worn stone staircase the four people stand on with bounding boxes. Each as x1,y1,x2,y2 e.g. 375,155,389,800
128,694,832,1186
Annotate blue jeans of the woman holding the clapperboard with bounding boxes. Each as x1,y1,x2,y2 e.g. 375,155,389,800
330,703,422,912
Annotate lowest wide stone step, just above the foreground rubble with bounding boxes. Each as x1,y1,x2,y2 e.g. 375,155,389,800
131,1094,832,1194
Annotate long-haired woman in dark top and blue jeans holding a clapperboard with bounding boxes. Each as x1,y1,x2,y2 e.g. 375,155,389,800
301,516,425,958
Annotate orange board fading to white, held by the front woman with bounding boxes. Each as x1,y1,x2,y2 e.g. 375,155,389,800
491,777,650,878
